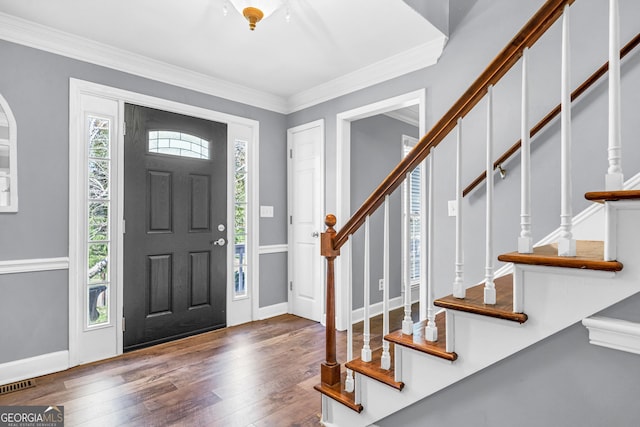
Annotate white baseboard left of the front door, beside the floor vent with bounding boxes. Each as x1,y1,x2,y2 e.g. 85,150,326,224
0,350,69,385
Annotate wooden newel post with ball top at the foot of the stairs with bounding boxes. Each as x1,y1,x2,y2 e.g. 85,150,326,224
320,214,340,385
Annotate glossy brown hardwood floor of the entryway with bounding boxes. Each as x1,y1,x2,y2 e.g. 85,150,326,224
0,307,417,427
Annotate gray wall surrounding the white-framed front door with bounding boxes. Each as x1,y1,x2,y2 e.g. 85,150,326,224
0,40,287,363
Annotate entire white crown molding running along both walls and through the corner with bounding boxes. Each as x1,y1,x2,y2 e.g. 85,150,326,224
0,12,447,114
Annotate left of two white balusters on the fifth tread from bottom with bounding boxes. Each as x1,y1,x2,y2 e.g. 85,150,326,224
518,47,533,254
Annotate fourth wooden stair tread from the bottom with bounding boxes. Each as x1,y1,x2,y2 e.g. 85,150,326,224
434,274,528,323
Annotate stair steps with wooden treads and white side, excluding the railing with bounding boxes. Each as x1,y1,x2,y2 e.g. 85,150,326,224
316,190,640,426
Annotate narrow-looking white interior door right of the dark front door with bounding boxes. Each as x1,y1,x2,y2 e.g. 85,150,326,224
287,120,324,321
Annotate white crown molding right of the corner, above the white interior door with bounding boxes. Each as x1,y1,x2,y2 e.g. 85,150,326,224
288,34,448,113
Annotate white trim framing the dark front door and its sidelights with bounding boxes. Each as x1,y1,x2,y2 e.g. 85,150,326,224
69,78,259,366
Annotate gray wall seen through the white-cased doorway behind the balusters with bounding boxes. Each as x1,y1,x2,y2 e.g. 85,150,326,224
351,115,418,308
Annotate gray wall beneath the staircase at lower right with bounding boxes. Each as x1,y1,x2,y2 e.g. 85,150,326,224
376,295,640,427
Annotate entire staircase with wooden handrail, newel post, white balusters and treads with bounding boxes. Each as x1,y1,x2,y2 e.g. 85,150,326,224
315,0,640,427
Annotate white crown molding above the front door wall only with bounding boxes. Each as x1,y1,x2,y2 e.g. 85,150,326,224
0,12,288,113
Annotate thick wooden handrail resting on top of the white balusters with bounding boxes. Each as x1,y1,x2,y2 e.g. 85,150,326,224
333,0,575,250
